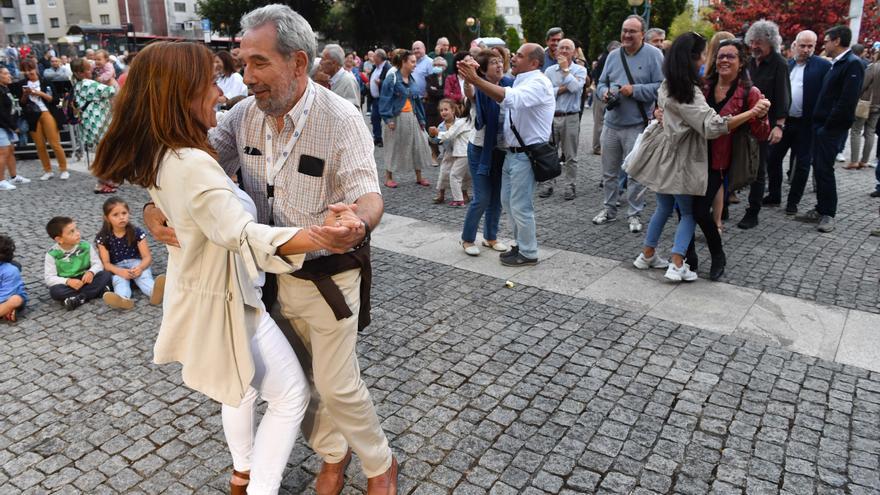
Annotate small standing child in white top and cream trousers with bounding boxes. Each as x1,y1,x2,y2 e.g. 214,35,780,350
428,98,473,206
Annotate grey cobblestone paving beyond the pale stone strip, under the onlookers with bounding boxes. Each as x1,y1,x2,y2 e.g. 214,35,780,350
376,112,880,313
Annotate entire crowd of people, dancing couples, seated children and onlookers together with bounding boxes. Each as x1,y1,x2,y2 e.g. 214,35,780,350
0,5,880,494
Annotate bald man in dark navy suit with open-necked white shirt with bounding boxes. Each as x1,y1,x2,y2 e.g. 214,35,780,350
763,30,831,215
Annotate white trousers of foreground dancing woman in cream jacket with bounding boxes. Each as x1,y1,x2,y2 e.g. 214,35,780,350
222,311,309,495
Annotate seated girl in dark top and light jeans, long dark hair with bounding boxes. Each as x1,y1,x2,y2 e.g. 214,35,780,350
95,196,165,309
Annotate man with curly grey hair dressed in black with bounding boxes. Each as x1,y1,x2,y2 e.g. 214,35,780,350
736,20,791,229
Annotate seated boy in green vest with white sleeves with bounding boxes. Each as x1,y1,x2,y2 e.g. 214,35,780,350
43,217,118,310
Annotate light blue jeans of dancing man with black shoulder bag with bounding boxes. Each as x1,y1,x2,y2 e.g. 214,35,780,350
501,151,536,259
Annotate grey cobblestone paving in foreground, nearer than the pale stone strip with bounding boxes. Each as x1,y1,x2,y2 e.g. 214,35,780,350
0,163,880,495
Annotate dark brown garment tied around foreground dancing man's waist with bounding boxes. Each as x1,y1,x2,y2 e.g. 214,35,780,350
291,243,373,332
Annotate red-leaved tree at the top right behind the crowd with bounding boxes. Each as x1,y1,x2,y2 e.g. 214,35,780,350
706,0,880,44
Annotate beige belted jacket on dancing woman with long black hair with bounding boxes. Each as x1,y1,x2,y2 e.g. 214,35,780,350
624,81,730,196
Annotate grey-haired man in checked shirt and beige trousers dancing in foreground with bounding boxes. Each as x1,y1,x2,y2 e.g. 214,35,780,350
144,4,397,495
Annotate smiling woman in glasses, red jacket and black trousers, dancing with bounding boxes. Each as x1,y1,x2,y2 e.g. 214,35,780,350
691,39,770,280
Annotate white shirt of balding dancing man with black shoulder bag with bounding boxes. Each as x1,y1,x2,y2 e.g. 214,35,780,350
501,69,556,147
